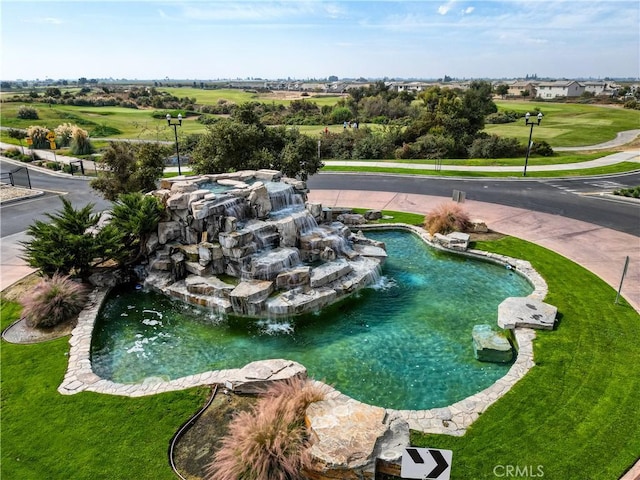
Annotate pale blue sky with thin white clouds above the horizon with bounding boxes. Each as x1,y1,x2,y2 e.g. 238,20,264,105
0,0,640,80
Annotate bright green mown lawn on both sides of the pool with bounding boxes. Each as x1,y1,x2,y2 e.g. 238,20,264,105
0,233,640,480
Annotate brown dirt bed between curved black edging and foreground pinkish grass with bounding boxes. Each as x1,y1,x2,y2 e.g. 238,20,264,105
173,390,257,480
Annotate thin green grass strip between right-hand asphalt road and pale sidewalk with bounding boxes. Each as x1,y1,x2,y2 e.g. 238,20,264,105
321,162,638,178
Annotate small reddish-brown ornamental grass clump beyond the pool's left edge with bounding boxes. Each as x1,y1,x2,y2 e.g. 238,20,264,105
22,275,87,328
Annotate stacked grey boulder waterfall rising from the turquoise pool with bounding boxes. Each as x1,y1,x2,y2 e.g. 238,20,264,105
145,170,386,316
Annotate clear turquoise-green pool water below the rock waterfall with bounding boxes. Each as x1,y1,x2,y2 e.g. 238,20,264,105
92,231,533,409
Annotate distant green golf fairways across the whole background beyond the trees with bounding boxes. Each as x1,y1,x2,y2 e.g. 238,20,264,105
0,99,640,147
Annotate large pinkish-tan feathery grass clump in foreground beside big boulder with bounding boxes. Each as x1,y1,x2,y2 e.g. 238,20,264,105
206,378,325,480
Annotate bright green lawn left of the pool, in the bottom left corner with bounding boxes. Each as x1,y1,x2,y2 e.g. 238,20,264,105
0,301,208,480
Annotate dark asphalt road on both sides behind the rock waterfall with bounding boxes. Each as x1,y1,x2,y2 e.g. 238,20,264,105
0,160,640,237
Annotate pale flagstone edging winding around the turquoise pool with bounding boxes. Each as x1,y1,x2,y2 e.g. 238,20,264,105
58,224,548,436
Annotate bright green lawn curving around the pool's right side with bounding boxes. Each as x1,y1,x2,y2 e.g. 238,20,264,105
412,238,640,480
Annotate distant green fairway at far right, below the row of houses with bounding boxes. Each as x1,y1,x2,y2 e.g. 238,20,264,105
485,101,640,147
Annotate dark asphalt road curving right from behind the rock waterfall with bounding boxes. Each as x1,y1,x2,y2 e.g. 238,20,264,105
307,173,640,236
